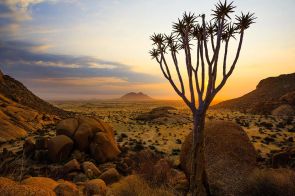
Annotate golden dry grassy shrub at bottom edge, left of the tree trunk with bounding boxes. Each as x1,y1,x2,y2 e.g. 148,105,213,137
107,175,174,196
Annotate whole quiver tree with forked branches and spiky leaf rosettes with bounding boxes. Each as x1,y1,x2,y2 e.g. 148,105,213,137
150,1,255,195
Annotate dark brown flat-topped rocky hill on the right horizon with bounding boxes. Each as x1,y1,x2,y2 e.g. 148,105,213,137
212,73,295,115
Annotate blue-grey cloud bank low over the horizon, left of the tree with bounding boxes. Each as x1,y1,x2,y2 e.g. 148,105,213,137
0,41,163,98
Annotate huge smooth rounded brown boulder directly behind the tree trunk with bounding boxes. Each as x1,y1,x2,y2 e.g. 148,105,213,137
180,121,257,195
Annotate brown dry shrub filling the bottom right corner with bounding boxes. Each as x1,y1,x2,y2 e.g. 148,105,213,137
243,168,295,196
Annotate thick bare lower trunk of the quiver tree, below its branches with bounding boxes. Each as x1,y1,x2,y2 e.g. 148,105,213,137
189,112,210,196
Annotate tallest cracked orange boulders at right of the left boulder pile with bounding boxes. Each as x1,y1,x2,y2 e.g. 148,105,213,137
56,117,120,162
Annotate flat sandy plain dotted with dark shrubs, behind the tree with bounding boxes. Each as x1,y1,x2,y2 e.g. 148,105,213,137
54,101,295,166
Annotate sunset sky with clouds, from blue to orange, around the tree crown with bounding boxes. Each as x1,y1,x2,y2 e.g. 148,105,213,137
0,0,295,100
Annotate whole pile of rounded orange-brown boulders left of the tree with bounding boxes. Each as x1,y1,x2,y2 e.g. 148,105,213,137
19,117,121,163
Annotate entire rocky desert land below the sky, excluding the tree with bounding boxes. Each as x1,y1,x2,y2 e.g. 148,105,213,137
0,69,295,196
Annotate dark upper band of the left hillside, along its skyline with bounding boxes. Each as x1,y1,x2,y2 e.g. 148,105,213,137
0,71,69,116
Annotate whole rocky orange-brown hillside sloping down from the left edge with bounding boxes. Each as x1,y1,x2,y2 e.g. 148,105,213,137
0,71,69,143
